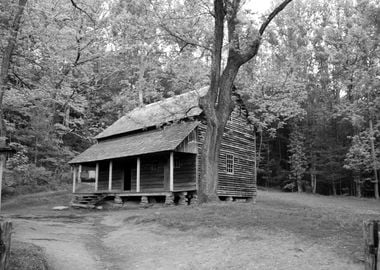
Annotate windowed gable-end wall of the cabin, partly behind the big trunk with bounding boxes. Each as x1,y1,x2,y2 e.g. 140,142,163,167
197,107,256,197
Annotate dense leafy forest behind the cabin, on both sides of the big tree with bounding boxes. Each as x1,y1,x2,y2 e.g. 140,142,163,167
0,0,380,197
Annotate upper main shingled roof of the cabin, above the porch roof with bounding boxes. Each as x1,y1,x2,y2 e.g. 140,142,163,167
95,87,208,139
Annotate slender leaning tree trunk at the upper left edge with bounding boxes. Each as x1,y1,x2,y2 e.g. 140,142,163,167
0,0,27,137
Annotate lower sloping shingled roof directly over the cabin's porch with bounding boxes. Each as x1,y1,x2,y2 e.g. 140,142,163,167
69,121,199,164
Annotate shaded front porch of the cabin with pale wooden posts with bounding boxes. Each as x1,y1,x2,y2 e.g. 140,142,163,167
72,151,198,197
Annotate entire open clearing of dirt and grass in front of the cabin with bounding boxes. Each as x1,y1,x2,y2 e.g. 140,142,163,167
2,191,380,270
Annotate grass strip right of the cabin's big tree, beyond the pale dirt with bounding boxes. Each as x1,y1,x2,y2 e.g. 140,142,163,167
124,193,378,261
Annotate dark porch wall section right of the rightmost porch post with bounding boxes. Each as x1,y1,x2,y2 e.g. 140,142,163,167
174,152,197,190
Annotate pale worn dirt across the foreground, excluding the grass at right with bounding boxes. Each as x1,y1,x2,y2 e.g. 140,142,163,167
5,193,375,270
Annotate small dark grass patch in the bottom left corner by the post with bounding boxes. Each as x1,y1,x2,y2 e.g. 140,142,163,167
8,241,48,270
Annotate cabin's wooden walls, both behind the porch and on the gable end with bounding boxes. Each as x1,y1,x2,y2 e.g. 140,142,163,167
87,103,256,198
